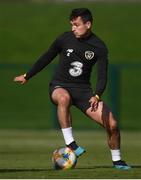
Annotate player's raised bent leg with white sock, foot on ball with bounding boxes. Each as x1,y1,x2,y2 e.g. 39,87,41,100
52,88,85,157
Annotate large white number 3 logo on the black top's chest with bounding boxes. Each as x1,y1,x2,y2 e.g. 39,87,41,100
69,61,83,77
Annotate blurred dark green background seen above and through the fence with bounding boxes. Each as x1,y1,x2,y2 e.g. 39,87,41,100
0,2,141,129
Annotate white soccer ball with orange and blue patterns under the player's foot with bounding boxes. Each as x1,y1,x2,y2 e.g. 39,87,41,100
52,147,77,170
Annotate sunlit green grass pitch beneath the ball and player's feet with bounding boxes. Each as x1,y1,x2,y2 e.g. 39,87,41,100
0,130,141,179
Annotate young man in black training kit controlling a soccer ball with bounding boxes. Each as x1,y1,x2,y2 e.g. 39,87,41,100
14,8,131,170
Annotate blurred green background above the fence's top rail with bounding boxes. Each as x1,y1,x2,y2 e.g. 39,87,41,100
0,2,141,63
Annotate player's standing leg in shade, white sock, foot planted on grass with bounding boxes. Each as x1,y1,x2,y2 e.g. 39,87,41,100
86,101,131,170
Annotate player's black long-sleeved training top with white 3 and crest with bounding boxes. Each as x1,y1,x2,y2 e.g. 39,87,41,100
26,32,108,96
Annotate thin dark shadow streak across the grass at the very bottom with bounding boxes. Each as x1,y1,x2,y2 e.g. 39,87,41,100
0,165,141,173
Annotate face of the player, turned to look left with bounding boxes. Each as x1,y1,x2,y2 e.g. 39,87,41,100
70,16,91,38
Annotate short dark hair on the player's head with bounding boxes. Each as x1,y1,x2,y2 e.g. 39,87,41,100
70,8,93,23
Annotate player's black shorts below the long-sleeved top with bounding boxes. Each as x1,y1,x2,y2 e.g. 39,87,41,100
50,84,93,113
